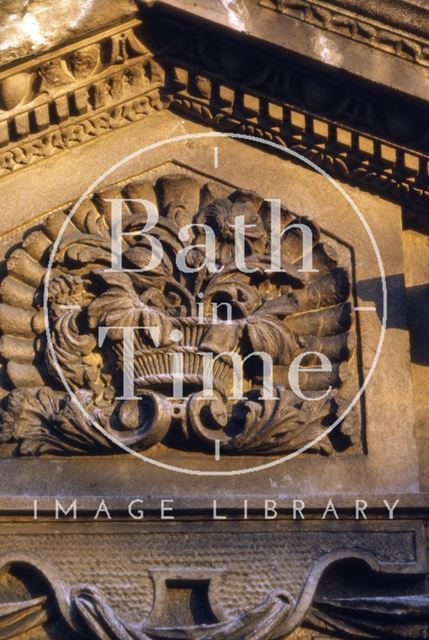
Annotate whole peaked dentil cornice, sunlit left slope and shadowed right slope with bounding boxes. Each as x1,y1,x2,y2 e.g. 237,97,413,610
0,11,429,210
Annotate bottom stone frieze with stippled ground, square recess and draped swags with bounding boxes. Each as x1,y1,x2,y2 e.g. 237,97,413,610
0,522,422,640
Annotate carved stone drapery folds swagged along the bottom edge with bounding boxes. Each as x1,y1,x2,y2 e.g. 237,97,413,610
0,568,429,640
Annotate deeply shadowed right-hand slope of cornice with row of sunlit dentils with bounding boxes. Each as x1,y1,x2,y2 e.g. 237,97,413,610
148,13,429,210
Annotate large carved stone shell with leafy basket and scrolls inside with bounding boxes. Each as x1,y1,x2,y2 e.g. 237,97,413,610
0,174,354,455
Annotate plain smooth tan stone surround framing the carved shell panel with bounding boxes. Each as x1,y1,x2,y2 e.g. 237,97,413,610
0,119,418,502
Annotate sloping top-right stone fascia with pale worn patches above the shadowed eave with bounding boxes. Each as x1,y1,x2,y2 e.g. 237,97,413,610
140,0,429,100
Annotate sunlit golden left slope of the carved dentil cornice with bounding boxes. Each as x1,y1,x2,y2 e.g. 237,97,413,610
0,19,164,175
